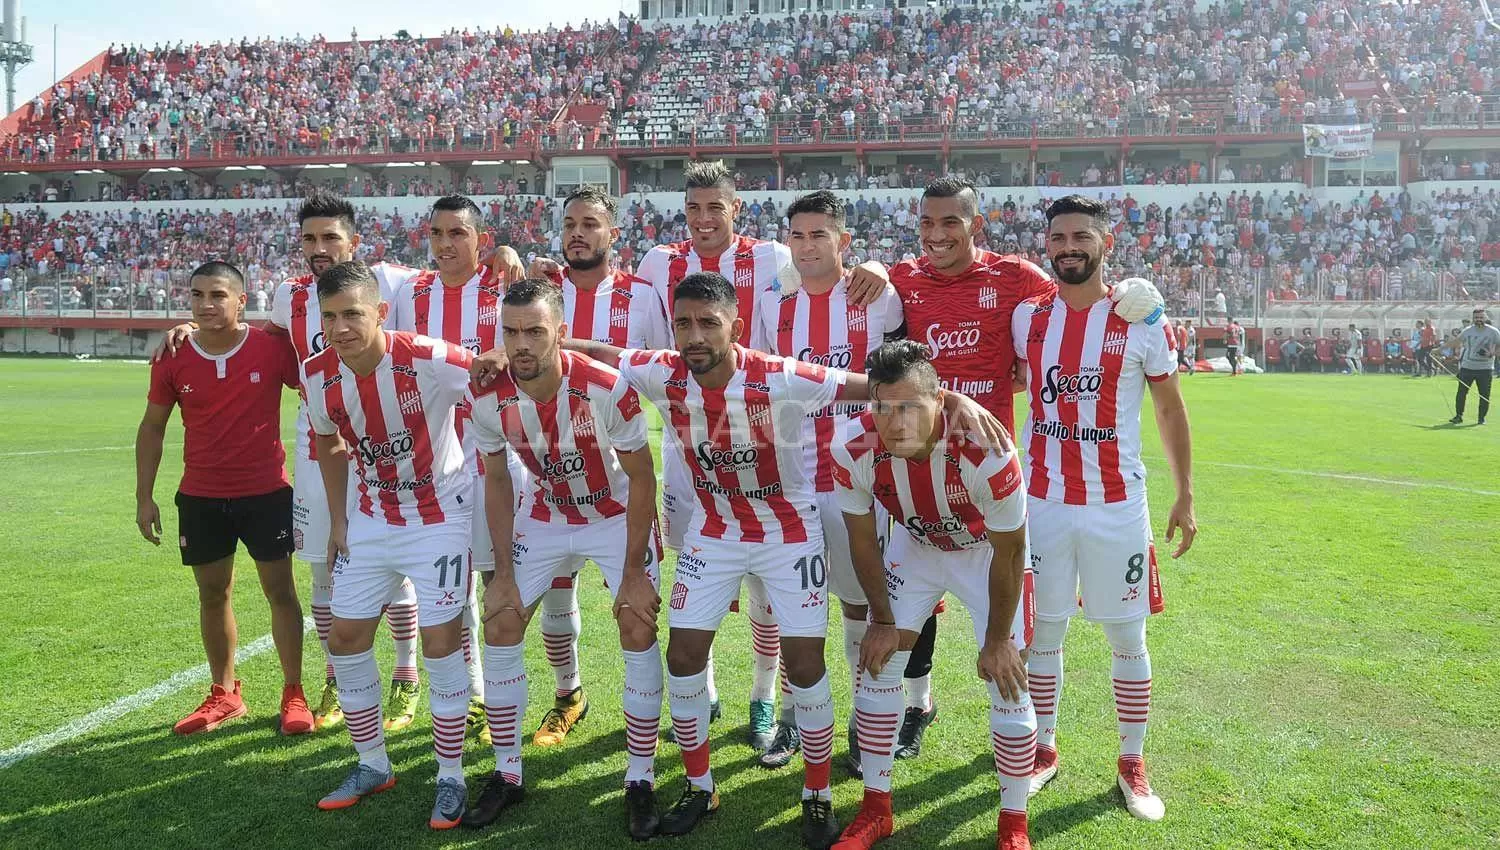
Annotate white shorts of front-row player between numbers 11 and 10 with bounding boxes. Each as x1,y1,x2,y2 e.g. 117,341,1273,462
512,514,662,607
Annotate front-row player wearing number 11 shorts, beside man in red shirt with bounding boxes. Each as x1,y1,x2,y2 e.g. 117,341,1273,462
302,262,474,829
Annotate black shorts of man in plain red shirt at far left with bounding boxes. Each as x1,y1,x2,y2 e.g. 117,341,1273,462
176,487,293,567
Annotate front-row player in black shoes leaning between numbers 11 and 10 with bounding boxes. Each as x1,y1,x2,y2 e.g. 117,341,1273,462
464,280,663,840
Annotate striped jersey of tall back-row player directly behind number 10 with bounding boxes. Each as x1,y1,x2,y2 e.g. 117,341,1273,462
636,237,792,345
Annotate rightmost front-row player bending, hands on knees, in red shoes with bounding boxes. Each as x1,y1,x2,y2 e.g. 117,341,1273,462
833,340,1037,850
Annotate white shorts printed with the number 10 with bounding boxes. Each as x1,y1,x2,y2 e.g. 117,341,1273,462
668,526,828,637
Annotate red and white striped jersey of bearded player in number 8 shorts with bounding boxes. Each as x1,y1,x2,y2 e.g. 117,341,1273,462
1011,294,1178,505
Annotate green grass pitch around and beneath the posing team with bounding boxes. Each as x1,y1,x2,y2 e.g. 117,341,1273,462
0,360,1500,849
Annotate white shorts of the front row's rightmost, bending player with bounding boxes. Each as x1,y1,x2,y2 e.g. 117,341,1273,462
885,531,1037,649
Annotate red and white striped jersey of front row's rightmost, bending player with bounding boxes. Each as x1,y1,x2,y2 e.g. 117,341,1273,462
833,412,1026,552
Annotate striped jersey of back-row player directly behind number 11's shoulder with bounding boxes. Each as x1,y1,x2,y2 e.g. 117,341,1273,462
387,265,503,475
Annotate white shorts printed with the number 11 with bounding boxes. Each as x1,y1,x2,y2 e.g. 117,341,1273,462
332,511,471,628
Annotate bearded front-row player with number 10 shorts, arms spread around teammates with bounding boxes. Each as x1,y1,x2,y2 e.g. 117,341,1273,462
552,273,1004,849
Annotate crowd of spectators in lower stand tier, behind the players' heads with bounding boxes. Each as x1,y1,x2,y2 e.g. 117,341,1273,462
0,187,1500,316
